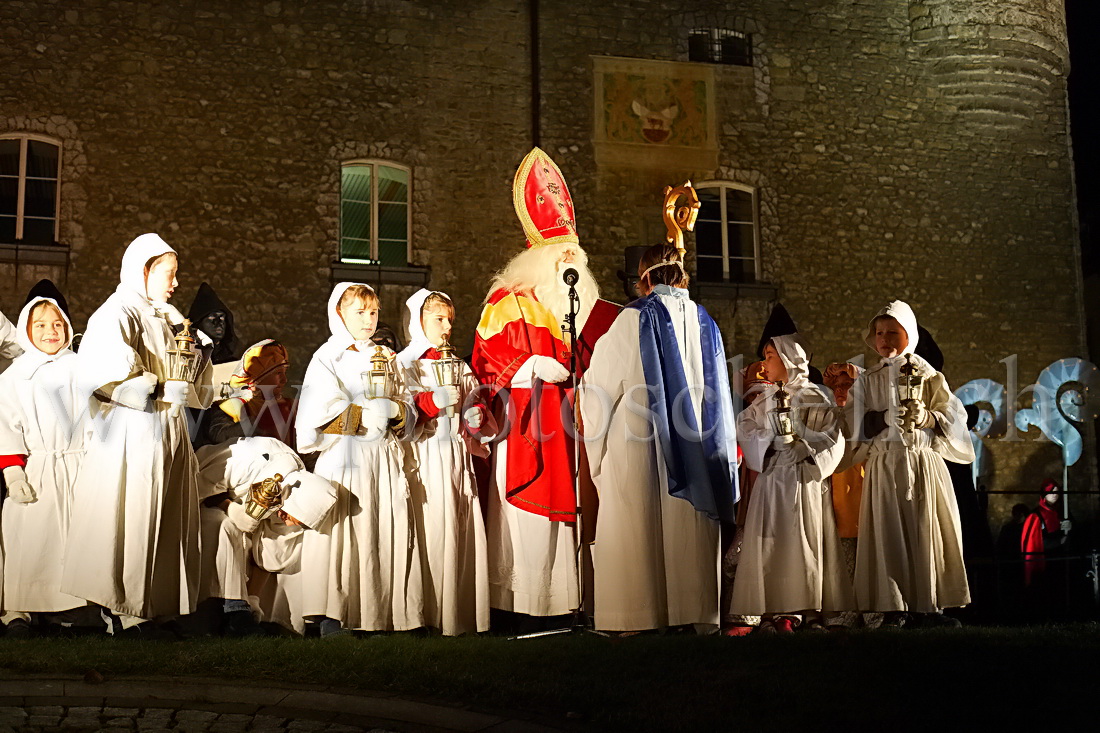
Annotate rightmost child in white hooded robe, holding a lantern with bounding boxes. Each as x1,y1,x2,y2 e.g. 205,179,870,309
845,300,974,626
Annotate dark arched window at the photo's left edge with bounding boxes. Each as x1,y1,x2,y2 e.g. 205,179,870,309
0,133,62,244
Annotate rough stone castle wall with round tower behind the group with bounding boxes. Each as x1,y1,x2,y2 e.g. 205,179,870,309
0,0,1095,521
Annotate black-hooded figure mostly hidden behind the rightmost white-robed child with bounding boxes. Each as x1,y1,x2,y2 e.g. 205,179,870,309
913,326,993,614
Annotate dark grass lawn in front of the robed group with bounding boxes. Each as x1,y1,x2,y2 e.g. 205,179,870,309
0,624,1100,732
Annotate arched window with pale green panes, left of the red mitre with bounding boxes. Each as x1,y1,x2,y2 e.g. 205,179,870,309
340,160,413,267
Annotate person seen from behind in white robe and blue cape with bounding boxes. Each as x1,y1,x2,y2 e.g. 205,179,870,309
579,244,737,632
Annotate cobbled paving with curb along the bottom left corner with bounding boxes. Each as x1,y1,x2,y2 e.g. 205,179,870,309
0,670,558,733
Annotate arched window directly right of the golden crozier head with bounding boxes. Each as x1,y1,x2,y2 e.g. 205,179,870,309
695,180,761,283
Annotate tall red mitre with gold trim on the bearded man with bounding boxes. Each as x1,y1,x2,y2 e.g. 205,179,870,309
512,147,580,248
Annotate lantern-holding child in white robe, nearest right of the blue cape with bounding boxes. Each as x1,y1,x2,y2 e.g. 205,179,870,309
730,335,855,633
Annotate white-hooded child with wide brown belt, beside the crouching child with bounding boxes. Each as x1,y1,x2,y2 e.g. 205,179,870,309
295,283,424,636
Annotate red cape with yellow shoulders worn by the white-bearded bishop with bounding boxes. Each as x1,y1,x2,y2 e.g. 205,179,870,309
471,289,618,522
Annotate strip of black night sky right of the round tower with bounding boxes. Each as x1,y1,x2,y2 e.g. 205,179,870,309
1066,0,1100,276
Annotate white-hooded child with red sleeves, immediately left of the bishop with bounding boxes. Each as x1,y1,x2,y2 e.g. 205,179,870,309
397,289,495,636
